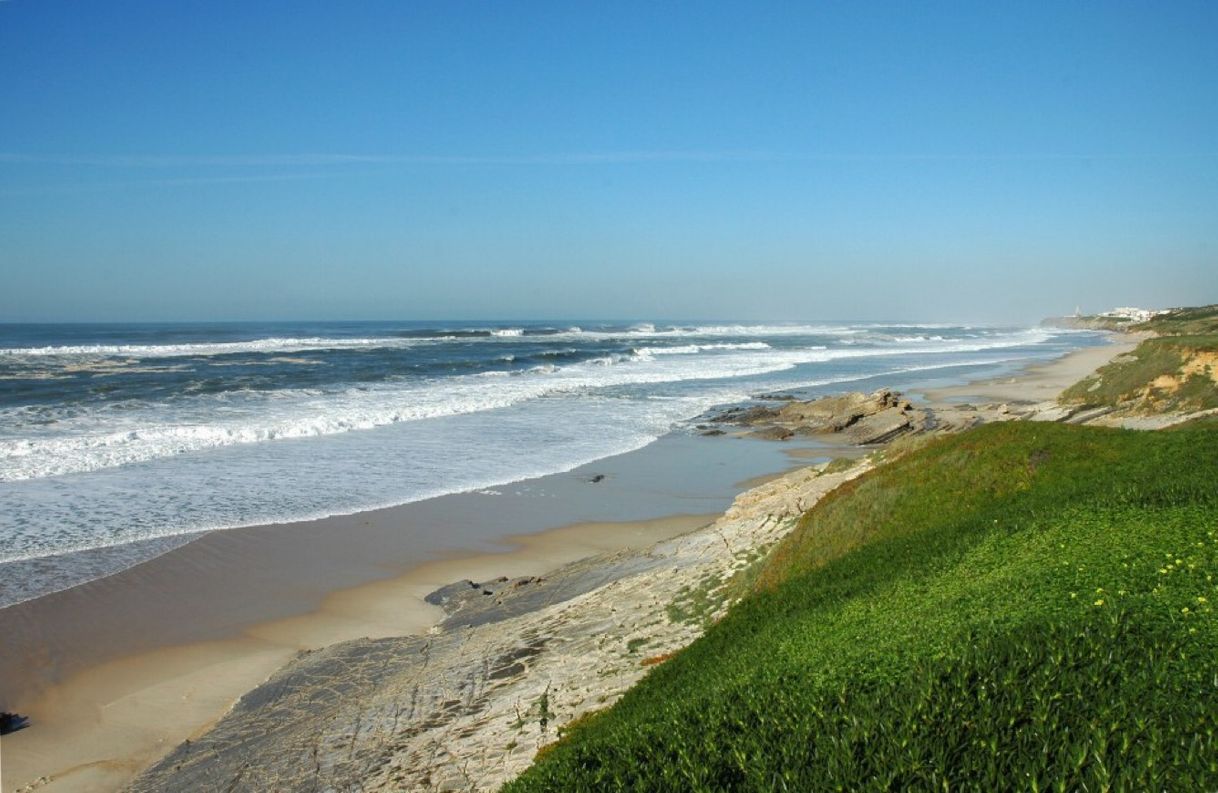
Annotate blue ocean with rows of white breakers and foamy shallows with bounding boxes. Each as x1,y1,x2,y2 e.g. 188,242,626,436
0,322,1100,607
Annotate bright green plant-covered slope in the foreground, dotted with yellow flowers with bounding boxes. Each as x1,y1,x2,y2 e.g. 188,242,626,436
507,423,1218,792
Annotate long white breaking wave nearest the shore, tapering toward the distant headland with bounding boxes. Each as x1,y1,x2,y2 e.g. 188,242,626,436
0,330,1047,481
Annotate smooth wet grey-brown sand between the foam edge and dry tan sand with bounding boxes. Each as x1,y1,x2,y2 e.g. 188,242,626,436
0,435,827,711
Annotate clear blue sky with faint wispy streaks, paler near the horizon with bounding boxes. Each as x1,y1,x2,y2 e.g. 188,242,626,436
0,0,1218,323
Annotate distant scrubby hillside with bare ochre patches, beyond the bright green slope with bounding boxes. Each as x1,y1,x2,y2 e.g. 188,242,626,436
1061,333,1218,412
